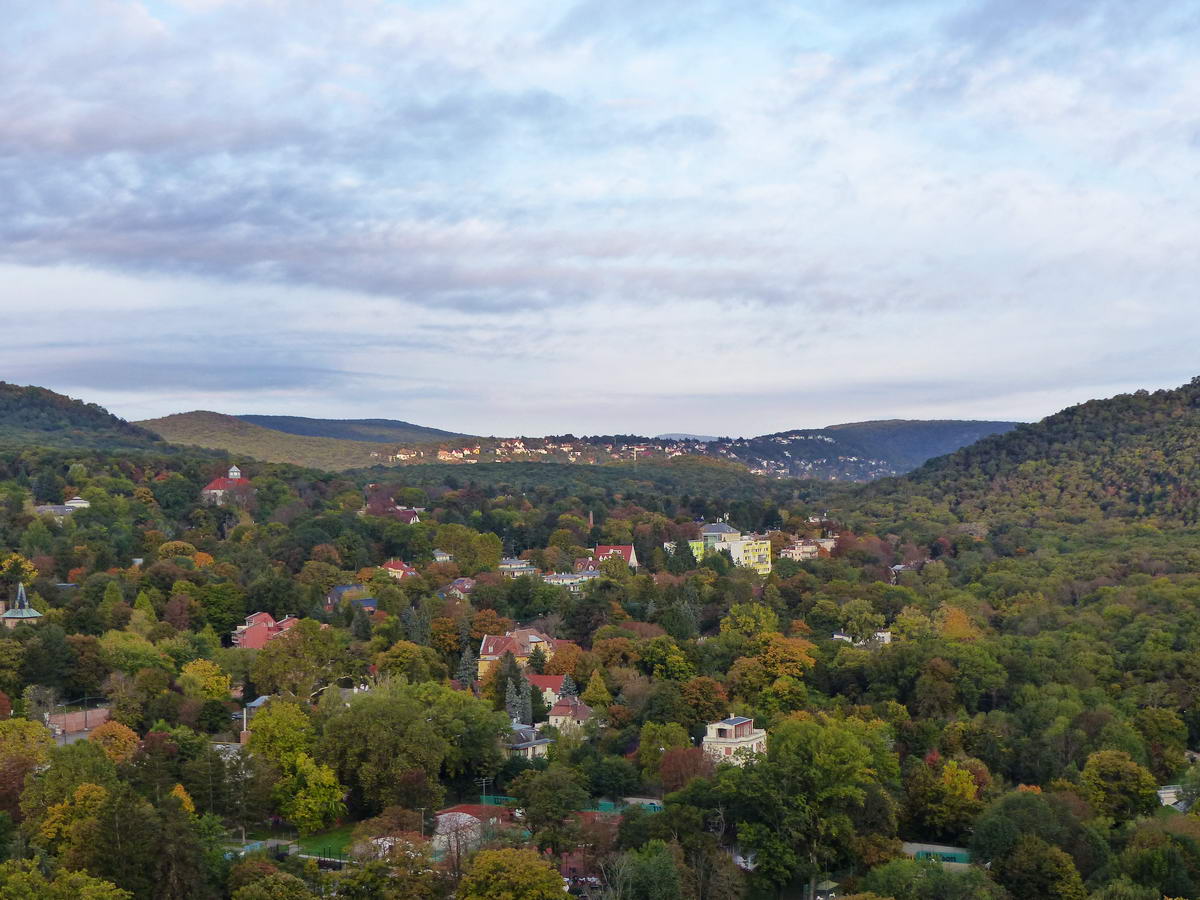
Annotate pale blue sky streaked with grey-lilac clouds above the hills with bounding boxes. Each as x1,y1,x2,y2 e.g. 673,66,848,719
0,0,1200,436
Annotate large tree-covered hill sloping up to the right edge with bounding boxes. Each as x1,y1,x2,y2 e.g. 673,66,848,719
868,378,1200,524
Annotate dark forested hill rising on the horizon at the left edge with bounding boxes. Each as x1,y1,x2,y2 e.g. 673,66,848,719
0,382,163,450
